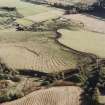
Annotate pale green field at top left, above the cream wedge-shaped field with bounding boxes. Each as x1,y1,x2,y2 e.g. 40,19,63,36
0,0,55,16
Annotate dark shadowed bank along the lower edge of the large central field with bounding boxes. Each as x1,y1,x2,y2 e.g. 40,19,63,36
18,69,79,81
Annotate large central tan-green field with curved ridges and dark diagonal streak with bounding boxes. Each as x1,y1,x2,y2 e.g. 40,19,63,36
0,31,78,73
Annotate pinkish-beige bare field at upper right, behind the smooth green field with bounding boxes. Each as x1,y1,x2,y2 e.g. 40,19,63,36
64,14,105,33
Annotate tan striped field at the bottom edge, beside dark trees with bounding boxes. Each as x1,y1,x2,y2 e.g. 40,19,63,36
1,86,82,105
